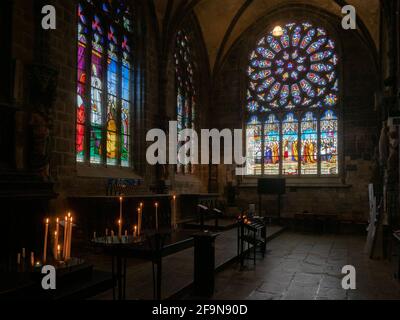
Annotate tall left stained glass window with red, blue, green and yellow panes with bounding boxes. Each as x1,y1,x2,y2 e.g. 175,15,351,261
76,0,133,167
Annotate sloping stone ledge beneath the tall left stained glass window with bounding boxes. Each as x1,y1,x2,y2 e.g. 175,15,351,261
77,164,143,180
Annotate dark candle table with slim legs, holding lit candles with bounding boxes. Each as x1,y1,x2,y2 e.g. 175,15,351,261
92,230,194,300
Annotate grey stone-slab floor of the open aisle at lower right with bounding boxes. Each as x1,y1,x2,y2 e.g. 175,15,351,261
208,232,400,300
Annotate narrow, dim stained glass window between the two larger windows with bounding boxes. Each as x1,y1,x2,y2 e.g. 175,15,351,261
174,30,197,174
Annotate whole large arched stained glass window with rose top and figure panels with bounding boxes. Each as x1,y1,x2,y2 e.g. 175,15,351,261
246,22,340,176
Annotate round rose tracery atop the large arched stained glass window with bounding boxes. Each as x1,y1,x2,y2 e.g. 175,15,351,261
248,23,338,109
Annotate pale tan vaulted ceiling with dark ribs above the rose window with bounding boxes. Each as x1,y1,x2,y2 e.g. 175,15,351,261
153,0,380,69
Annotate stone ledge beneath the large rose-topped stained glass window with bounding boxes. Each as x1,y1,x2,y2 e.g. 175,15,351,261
239,177,352,189
